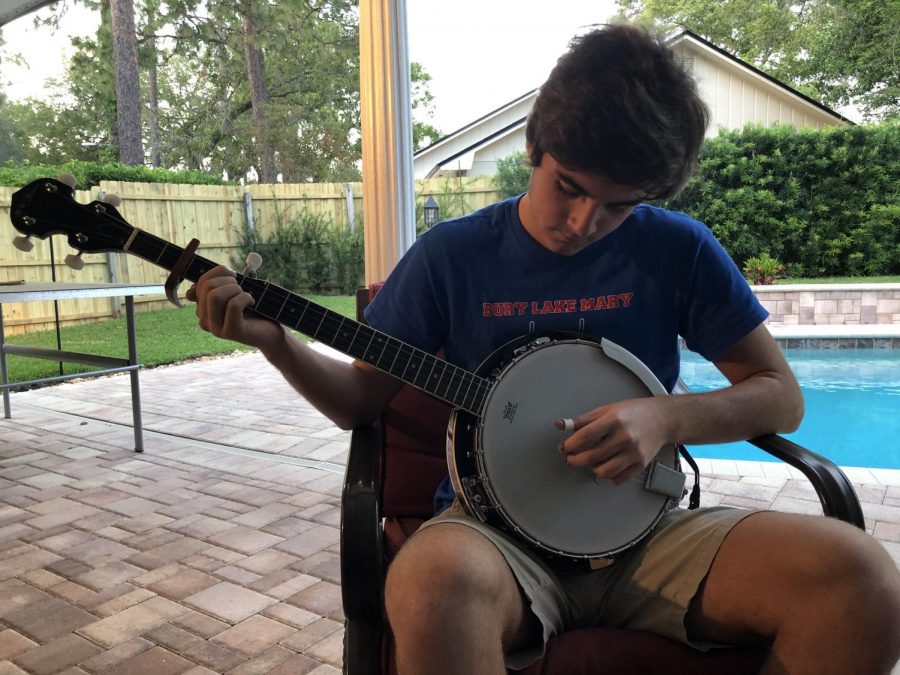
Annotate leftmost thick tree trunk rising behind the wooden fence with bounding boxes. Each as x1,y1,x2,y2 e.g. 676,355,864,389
109,0,144,166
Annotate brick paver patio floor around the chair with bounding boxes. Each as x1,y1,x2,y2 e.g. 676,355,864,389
0,354,900,675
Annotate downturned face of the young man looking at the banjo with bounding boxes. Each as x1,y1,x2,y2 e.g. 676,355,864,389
519,148,641,255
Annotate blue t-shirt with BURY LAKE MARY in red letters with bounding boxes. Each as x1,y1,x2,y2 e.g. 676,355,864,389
366,197,767,510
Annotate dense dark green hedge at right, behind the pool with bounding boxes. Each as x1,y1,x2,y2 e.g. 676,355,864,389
666,123,900,277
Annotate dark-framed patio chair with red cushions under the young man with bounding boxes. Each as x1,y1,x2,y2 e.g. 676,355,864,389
341,289,864,675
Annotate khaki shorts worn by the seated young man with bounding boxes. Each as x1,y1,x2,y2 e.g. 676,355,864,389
422,502,757,670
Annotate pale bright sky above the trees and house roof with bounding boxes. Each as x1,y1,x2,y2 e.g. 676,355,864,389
0,0,615,134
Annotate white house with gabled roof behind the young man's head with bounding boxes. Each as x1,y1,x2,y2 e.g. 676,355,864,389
413,30,852,178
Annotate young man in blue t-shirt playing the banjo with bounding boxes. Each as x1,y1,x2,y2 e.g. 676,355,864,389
190,25,900,675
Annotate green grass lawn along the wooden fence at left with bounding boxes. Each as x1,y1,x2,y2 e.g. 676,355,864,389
7,295,356,382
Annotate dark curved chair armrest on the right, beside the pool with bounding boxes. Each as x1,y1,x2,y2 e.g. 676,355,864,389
748,434,866,530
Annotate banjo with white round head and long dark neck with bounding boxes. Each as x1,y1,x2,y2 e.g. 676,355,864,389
10,178,685,560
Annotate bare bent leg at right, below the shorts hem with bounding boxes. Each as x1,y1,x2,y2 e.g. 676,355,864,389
686,512,900,675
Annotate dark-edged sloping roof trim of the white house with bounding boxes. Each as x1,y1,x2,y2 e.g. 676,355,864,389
414,29,854,171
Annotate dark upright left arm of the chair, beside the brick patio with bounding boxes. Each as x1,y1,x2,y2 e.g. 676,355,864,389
340,421,384,674
